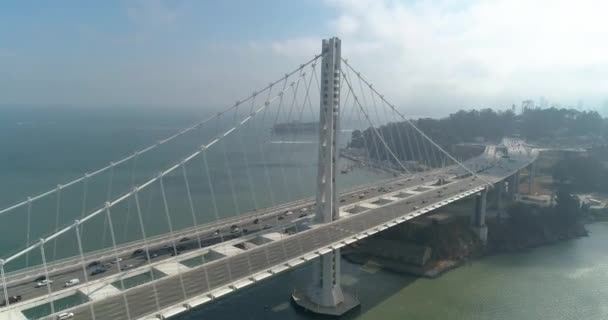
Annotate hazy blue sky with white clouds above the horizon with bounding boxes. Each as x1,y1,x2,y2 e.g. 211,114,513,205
0,0,608,116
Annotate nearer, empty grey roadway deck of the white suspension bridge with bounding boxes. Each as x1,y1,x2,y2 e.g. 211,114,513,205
0,146,530,319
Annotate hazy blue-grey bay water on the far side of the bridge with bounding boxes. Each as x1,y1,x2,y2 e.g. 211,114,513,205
0,109,386,270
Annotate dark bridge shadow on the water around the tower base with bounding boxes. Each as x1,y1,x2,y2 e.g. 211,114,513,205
175,260,417,320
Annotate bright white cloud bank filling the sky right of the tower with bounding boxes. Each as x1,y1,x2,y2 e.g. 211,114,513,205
273,0,608,114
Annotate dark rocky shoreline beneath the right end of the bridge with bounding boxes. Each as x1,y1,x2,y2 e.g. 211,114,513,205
342,208,587,278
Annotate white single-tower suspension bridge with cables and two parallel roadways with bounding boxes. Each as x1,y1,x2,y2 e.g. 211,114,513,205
0,38,537,320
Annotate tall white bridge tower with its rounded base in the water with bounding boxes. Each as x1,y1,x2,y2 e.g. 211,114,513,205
292,37,359,316
